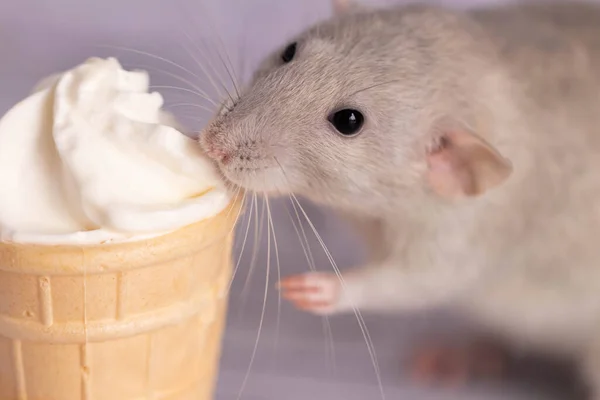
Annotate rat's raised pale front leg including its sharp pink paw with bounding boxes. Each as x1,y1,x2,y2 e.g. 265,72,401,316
279,261,472,315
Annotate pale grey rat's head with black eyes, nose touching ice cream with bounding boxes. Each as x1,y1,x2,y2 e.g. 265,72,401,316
200,0,510,216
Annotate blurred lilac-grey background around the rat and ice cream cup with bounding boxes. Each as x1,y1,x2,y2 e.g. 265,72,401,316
0,0,575,400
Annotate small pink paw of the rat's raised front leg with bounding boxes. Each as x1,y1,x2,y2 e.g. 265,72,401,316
278,272,341,315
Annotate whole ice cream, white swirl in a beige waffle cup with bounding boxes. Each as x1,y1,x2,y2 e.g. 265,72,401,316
0,59,242,400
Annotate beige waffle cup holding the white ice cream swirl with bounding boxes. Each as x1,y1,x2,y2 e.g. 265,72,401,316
0,198,239,400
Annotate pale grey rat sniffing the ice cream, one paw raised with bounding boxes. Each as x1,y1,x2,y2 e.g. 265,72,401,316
200,0,600,399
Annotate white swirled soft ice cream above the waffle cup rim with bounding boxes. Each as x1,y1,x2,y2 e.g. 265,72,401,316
0,58,231,244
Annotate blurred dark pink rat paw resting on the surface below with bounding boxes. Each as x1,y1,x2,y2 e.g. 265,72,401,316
411,343,508,387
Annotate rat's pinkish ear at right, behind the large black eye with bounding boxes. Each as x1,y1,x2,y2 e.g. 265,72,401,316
427,130,512,198
